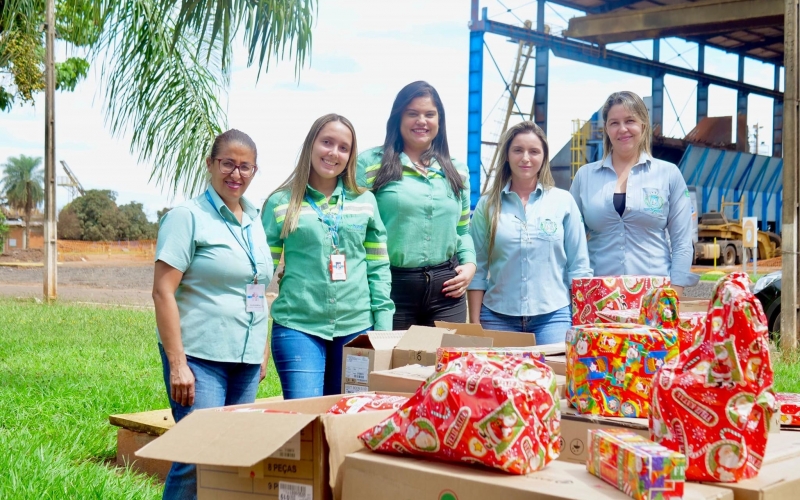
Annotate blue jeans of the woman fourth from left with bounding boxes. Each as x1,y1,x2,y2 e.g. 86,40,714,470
481,305,572,345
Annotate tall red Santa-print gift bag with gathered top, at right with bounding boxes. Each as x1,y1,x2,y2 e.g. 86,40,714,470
650,273,777,482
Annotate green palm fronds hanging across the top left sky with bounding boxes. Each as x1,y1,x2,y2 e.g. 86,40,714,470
0,0,317,194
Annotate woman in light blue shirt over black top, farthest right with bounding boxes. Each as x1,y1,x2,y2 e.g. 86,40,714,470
570,92,699,294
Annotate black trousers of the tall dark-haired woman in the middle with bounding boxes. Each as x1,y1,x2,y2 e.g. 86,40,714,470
391,256,467,330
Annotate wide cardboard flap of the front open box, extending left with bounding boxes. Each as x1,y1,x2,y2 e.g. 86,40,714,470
136,411,317,467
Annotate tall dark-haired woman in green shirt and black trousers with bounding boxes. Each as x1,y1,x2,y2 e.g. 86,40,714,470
358,81,476,330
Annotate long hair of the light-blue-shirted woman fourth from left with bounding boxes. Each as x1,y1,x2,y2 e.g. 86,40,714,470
484,121,556,262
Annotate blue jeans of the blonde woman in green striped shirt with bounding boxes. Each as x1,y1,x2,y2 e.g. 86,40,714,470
272,323,370,399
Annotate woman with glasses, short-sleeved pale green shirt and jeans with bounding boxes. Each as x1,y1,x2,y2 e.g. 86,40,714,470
153,130,273,499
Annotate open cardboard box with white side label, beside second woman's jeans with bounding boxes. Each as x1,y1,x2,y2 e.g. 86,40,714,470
342,331,405,394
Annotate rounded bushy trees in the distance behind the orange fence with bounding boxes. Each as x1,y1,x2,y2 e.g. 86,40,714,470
58,189,158,241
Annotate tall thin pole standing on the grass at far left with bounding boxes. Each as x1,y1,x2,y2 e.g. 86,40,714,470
44,0,58,302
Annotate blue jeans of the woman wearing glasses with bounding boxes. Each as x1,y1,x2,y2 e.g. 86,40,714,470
158,342,261,500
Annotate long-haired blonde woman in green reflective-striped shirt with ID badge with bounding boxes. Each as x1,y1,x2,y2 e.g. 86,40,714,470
261,114,394,399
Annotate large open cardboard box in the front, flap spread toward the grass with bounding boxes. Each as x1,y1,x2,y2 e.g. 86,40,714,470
136,395,407,500
